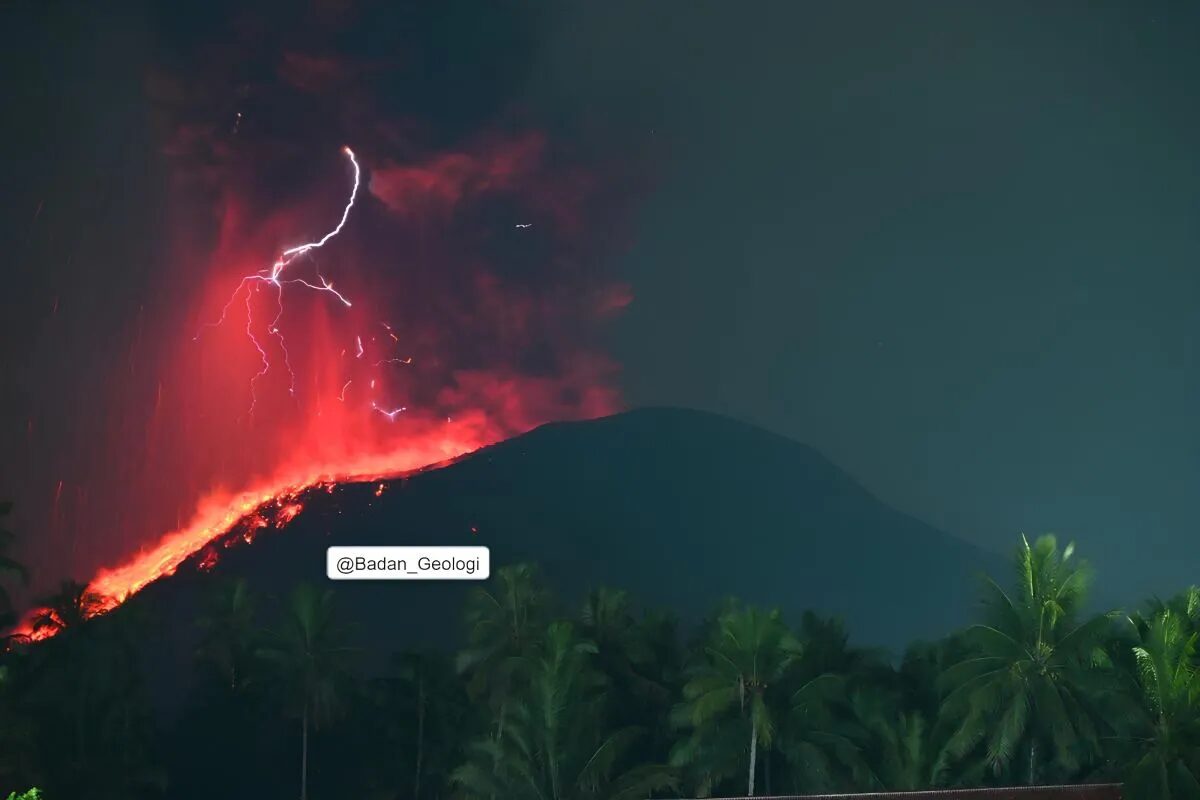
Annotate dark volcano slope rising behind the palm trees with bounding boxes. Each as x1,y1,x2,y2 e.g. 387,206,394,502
121,409,1006,666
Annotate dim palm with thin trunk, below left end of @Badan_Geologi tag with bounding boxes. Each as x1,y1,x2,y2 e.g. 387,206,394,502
263,583,353,800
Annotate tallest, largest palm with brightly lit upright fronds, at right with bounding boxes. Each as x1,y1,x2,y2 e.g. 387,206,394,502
942,535,1111,784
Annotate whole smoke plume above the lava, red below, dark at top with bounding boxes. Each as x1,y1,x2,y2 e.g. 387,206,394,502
9,2,631,618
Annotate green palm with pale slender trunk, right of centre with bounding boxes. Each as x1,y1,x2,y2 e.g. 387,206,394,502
671,607,800,796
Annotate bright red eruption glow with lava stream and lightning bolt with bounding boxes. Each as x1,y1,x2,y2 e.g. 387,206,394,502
18,118,628,639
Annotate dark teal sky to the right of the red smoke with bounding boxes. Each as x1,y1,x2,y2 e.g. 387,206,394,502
528,2,1200,599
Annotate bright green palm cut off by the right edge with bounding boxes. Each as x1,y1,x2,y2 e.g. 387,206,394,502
1126,607,1200,800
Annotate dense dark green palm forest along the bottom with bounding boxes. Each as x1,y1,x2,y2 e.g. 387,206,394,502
0,513,1200,800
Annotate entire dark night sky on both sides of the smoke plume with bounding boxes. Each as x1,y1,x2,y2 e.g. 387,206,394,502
0,1,1200,601
